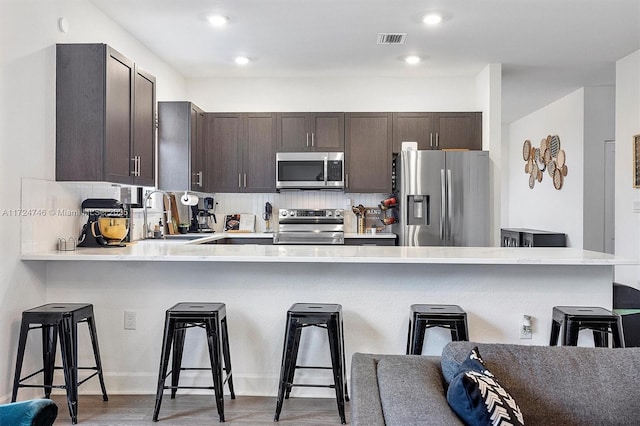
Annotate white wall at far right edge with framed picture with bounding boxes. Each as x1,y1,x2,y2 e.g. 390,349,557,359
615,51,640,288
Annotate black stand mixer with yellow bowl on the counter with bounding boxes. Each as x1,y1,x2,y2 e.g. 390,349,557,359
78,198,129,247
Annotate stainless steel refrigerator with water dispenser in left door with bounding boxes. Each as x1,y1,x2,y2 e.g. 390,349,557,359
393,150,490,247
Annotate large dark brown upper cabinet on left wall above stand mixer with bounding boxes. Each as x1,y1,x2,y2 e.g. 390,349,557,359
56,44,156,186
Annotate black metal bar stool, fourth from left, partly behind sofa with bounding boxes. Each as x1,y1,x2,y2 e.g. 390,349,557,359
407,304,469,355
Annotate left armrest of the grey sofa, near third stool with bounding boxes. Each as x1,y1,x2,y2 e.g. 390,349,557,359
350,352,385,426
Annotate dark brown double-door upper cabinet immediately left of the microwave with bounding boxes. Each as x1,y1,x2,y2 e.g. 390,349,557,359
205,113,276,193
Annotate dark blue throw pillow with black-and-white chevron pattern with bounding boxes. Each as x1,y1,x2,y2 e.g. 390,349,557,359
447,347,524,426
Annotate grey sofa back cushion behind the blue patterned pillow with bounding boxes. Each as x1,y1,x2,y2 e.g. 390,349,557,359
441,342,640,425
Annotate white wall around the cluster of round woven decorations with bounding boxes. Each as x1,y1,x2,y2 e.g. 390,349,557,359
503,89,584,248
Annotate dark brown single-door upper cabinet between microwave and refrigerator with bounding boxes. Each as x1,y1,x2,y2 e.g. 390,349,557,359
345,112,393,193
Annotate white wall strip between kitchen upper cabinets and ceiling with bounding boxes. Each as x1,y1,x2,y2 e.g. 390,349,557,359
187,77,479,112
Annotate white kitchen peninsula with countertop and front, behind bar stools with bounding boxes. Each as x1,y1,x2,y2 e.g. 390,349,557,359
22,245,637,397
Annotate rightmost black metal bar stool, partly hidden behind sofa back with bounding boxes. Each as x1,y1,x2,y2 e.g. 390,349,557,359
549,306,624,348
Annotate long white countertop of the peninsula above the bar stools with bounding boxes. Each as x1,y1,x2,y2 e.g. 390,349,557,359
21,241,640,265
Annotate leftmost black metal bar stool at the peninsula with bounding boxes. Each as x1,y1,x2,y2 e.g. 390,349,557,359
11,303,109,424
